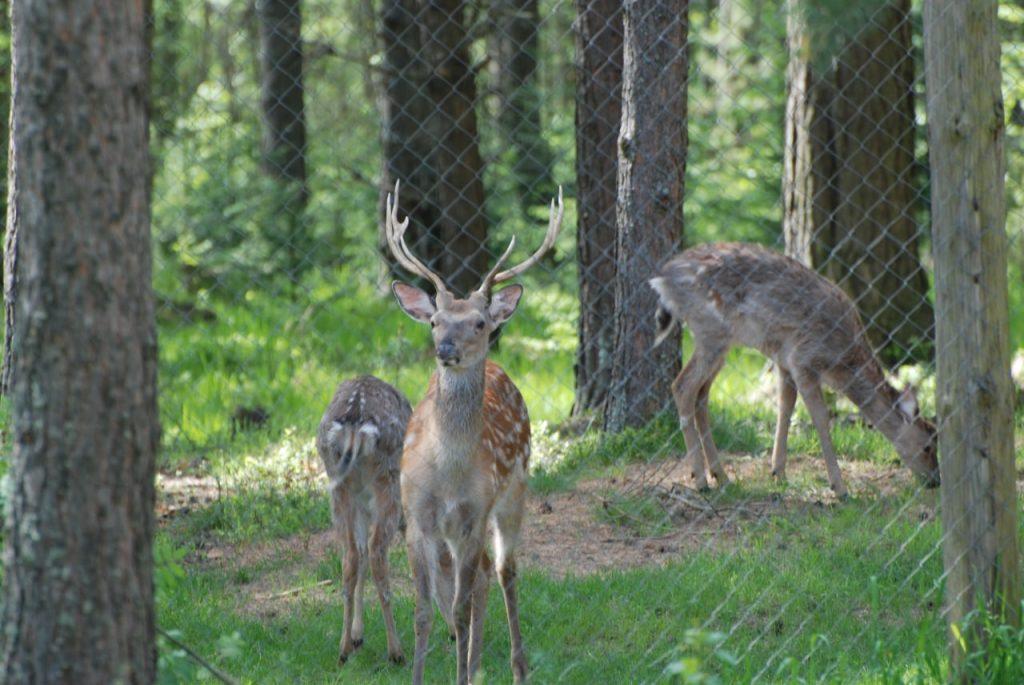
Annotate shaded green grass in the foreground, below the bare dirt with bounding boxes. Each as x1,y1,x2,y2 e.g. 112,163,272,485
160,483,943,683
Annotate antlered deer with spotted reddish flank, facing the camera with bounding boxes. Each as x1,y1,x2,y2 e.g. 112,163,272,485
386,183,562,685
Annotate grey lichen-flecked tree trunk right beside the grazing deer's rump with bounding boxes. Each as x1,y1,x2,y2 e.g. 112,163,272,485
605,0,688,431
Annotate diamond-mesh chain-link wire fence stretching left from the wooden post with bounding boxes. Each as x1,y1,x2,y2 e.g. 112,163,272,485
153,0,1024,682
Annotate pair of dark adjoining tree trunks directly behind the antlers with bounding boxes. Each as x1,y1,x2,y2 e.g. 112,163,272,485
381,0,489,295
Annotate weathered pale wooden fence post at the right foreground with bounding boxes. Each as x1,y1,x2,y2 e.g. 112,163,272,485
924,0,1021,671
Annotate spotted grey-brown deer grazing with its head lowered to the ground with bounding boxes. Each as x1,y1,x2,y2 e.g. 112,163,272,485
650,243,939,497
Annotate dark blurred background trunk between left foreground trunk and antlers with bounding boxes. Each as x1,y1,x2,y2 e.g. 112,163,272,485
256,0,311,281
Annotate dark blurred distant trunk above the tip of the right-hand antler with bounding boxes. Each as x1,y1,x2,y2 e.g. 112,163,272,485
492,0,555,211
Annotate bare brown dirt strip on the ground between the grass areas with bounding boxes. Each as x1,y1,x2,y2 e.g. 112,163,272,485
158,456,936,616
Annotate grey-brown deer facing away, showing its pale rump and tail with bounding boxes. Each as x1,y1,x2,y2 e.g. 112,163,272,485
316,376,413,665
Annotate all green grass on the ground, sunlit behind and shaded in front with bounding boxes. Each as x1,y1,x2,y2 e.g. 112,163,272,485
114,277,1024,683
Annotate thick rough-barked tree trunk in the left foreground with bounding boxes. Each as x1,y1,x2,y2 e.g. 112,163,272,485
0,0,159,684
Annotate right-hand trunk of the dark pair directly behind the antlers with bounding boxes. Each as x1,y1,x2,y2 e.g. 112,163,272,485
420,0,489,295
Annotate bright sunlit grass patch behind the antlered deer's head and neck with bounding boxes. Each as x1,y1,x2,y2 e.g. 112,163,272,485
160,273,575,466
